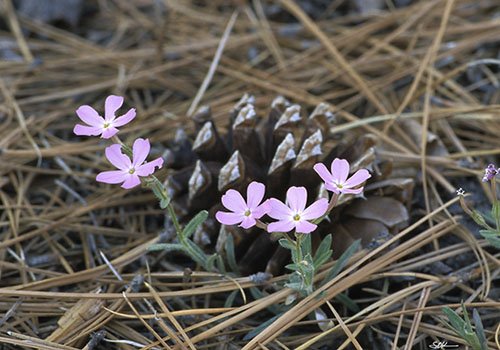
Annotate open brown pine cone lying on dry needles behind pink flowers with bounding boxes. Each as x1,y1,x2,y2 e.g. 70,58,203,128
166,95,413,275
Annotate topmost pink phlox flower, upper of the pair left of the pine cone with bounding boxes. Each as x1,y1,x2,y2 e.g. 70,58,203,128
73,95,135,139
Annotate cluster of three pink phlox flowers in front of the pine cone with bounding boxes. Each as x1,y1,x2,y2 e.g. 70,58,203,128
215,158,371,233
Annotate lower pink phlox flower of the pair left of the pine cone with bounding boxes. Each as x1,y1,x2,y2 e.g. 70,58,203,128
96,139,163,189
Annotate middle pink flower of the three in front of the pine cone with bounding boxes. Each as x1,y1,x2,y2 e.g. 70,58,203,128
267,186,328,233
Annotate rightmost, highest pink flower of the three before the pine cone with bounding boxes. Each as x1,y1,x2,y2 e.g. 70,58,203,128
313,158,371,194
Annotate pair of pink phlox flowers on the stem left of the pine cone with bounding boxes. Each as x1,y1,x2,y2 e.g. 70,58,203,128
73,95,163,189
